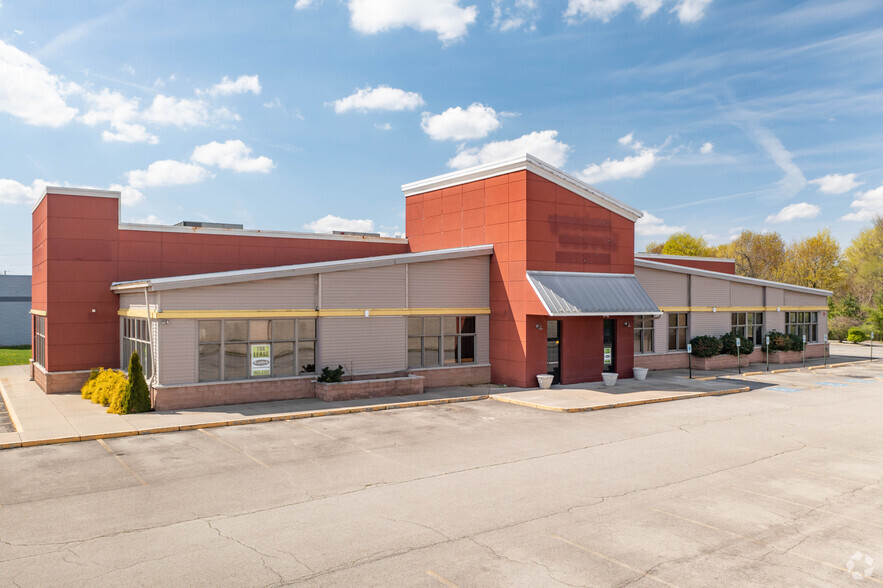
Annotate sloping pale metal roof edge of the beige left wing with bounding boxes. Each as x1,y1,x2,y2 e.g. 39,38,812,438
111,245,494,292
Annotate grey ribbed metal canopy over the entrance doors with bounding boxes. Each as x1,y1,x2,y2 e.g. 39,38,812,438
527,271,662,317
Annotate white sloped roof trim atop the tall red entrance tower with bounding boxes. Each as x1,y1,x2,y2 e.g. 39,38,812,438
402,153,644,221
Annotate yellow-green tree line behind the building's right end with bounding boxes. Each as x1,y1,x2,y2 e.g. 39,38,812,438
646,216,883,341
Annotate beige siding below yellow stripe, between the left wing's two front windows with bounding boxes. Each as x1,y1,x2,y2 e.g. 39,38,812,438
317,316,408,374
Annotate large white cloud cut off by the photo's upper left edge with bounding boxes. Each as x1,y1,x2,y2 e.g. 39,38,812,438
0,41,79,127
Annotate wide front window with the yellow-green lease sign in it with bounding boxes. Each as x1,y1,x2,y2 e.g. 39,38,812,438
199,318,316,382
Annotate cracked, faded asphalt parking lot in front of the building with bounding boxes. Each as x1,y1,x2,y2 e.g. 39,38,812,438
0,362,883,586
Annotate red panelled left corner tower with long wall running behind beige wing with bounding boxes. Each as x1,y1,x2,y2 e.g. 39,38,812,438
32,194,408,372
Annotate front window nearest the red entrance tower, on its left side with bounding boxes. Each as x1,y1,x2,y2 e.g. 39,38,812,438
408,316,475,368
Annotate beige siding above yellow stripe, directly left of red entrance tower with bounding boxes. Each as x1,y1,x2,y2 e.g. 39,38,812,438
408,256,490,308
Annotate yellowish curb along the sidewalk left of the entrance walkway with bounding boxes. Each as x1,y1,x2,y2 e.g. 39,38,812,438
0,394,488,450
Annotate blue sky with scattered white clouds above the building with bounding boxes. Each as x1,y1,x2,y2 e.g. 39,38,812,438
0,0,883,273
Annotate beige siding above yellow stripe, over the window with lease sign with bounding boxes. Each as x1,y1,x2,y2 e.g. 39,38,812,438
162,276,316,310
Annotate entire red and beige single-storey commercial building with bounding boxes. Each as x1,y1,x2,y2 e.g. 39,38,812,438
32,156,830,408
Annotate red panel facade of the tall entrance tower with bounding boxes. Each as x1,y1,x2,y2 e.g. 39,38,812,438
406,171,634,386
